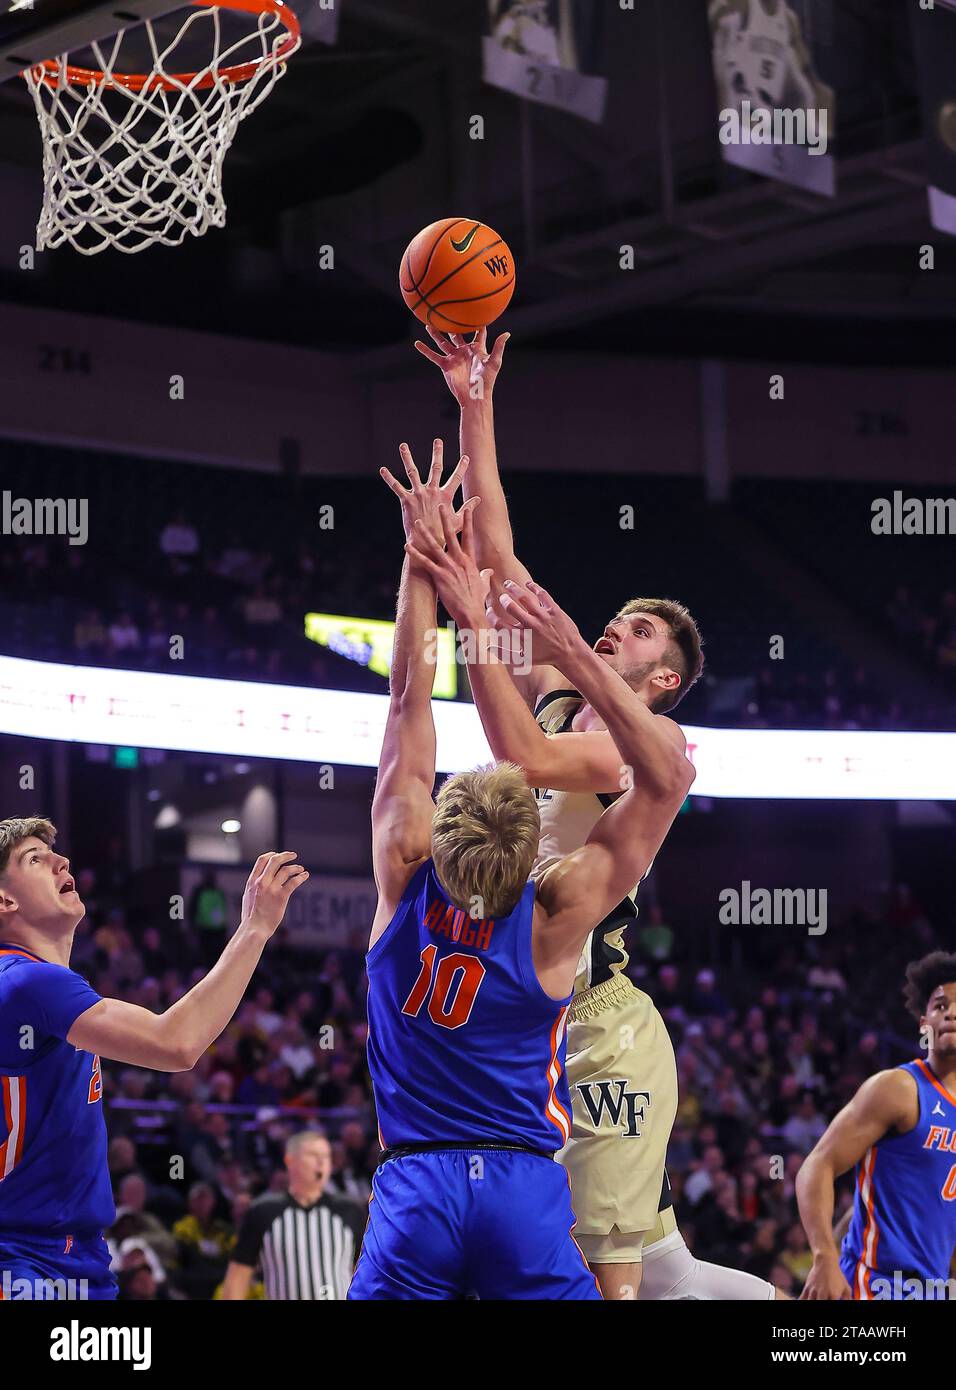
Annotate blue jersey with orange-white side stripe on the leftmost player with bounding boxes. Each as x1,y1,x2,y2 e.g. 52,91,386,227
0,942,115,1243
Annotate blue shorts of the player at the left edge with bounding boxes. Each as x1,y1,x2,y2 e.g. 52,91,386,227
0,1232,117,1301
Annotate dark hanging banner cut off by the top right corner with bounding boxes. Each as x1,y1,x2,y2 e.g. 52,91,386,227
910,0,956,235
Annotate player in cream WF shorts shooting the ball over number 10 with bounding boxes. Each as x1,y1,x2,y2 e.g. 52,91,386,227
415,329,785,1300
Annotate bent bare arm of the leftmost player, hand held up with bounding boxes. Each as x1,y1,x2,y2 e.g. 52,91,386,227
67,851,308,1072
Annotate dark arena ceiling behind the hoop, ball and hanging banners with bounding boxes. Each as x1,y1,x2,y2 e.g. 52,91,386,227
0,0,956,371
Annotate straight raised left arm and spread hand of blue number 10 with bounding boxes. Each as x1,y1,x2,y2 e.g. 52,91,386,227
372,439,477,937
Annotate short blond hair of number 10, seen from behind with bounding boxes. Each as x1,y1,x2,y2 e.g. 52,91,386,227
432,763,541,917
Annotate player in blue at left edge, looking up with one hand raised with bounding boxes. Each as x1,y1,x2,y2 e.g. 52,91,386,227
0,816,308,1300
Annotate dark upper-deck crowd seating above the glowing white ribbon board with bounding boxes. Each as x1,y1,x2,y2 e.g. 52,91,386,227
0,444,956,730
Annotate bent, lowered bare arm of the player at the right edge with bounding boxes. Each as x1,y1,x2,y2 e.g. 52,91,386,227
796,1069,918,1300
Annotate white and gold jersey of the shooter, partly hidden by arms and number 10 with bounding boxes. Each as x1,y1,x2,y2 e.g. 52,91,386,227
532,689,638,994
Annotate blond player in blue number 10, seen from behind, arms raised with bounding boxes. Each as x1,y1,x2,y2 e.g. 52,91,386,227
349,442,692,1300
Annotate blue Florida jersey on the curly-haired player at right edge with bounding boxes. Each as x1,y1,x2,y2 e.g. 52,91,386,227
841,1058,956,1298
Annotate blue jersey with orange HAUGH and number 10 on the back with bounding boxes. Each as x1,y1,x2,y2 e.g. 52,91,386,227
365,859,571,1154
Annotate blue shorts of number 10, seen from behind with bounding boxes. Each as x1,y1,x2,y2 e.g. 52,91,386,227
349,1150,600,1300
